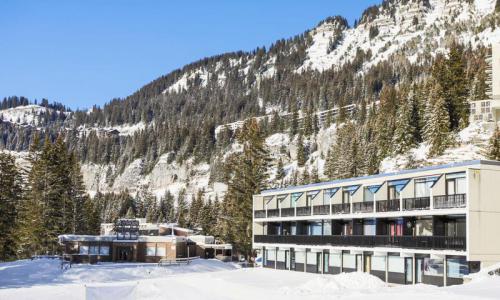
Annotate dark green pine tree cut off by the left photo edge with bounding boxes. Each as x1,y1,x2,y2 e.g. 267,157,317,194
0,153,23,261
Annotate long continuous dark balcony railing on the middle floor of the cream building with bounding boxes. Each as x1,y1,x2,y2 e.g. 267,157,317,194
254,235,466,250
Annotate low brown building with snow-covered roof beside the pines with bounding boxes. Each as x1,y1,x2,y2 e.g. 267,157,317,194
59,219,232,263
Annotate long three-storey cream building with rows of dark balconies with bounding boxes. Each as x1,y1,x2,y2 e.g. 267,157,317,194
253,161,500,286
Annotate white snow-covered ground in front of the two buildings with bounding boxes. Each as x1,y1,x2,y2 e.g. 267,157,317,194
0,260,500,300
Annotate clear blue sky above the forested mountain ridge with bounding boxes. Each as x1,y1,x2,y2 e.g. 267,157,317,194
0,0,381,109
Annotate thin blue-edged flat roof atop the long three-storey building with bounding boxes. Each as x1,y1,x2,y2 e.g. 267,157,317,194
260,160,500,195
